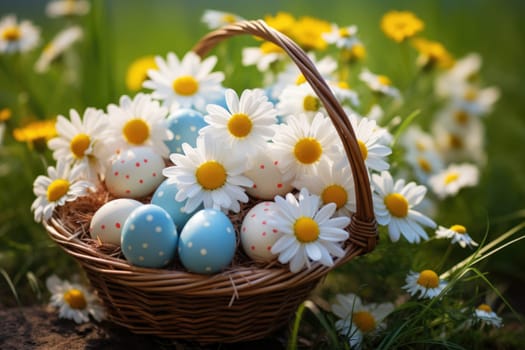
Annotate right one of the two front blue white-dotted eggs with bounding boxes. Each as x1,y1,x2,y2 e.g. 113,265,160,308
178,209,236,274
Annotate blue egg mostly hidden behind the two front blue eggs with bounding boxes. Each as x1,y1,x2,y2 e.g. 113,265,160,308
151,179,202,232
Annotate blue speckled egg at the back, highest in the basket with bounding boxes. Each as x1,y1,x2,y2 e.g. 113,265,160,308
165,108,208,153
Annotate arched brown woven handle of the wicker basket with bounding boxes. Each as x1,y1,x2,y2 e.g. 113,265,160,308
192,20,378,254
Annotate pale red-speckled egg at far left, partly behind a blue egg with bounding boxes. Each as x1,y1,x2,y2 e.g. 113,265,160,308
89,198,142,245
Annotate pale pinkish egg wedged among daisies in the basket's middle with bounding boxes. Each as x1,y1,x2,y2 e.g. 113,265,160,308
244,152,293,199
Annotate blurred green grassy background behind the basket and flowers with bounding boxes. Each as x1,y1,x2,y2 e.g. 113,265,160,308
0,0,525,318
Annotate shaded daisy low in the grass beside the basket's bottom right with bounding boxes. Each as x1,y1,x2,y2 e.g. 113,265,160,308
332,294,394,338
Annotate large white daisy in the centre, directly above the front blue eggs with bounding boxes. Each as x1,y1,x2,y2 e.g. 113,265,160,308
162,135,253,213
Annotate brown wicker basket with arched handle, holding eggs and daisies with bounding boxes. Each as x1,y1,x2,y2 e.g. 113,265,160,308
44,20,378,343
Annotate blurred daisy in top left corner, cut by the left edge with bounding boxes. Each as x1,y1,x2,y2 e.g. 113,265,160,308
0,15,40,53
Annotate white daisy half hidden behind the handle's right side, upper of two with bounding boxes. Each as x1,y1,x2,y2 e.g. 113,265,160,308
348,113,392,171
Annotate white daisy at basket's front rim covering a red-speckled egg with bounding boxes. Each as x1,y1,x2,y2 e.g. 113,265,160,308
271,188,350,272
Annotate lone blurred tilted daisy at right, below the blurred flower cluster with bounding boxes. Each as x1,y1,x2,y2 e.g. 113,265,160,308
429,163,479,199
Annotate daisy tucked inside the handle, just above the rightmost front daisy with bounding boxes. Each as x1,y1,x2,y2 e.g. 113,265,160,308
292,158,356,217
